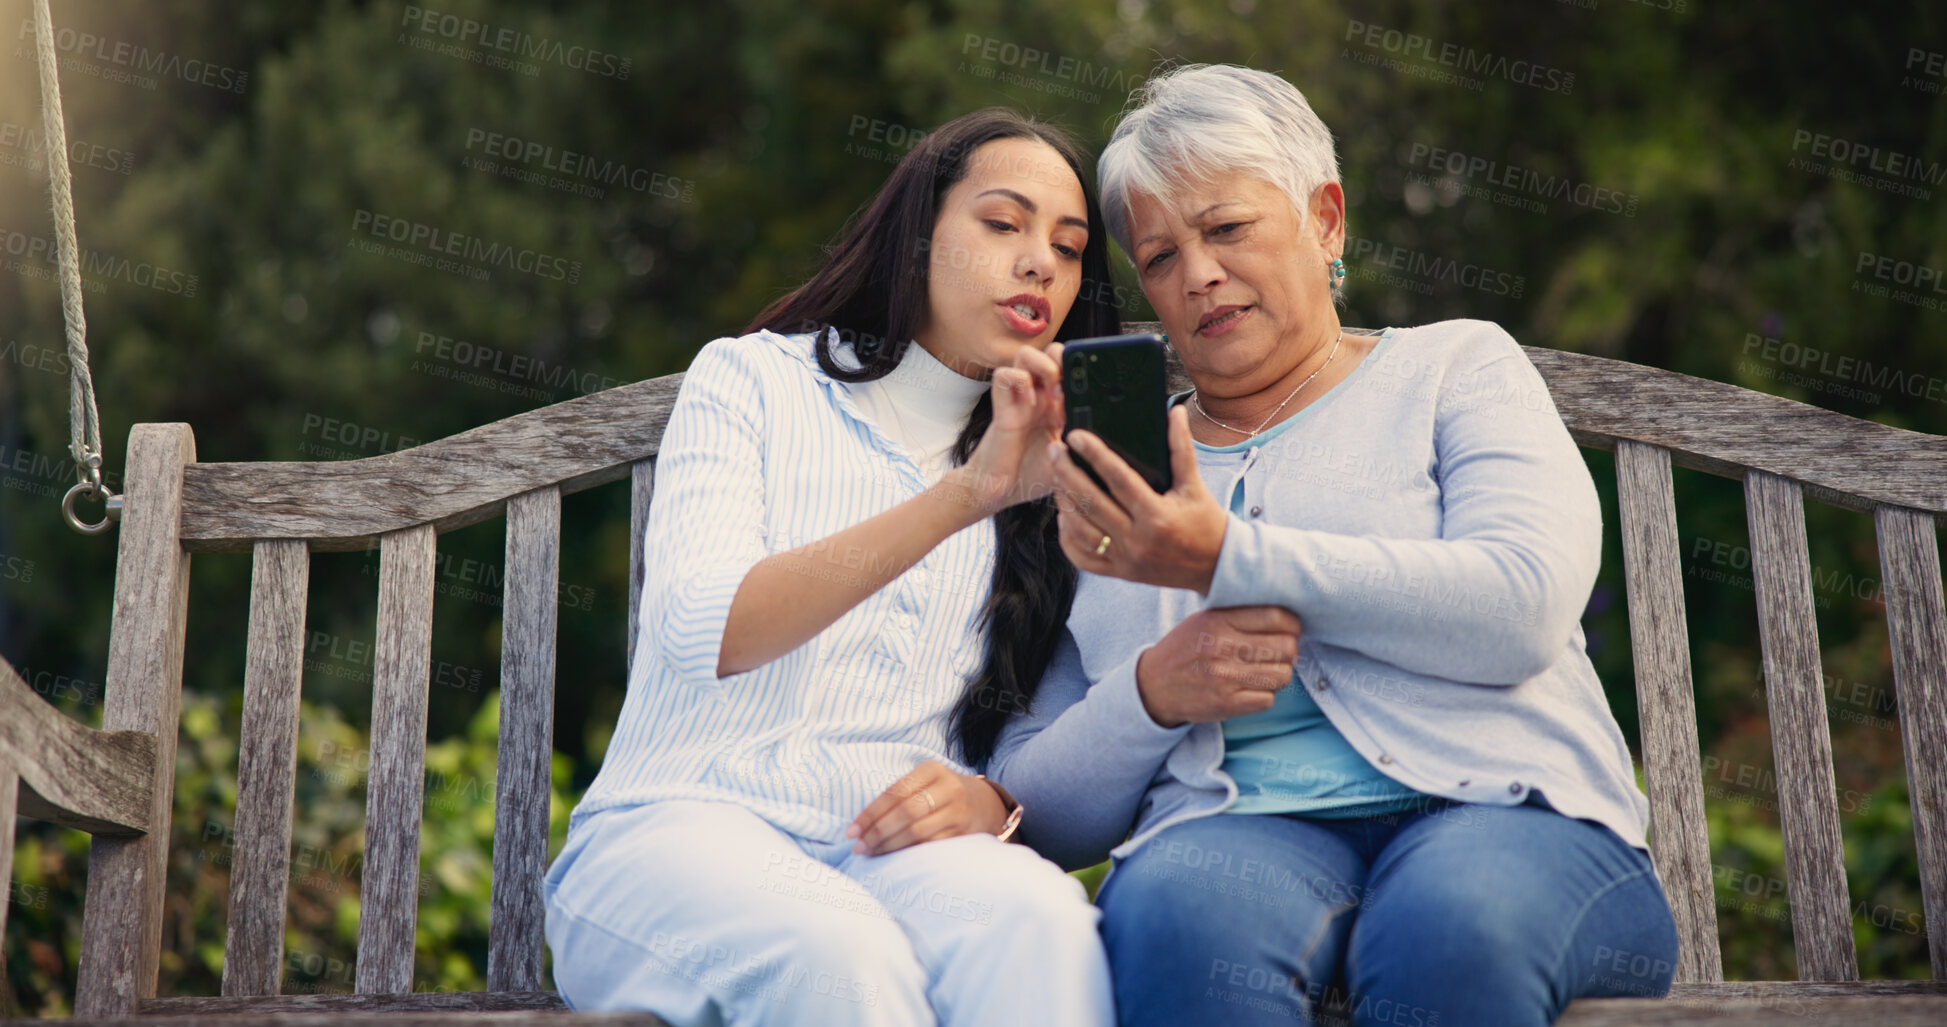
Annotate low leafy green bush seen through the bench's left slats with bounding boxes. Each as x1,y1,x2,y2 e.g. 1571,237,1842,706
8,692,576,1015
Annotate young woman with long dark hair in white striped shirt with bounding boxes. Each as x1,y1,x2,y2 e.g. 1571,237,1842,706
547,109,1118,1027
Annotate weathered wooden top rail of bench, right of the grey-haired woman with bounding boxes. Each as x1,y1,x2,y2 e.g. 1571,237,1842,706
1123,322,1947,514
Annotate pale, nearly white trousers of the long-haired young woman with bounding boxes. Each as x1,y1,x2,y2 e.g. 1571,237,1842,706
547,799,1116,1027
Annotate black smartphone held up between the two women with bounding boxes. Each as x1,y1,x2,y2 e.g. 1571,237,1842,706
1061,333,1170,493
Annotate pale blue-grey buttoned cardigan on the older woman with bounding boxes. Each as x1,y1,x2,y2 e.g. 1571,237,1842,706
987,322,1649,869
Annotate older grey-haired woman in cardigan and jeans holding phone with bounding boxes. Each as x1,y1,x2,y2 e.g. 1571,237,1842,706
989,66,1676,1027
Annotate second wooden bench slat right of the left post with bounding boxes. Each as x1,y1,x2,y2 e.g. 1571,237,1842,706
358,524,434,994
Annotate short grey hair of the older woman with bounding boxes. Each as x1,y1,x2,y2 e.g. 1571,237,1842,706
1096,64,1340,259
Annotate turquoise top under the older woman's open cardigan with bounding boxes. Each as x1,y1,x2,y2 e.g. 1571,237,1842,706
1197,331,1425,817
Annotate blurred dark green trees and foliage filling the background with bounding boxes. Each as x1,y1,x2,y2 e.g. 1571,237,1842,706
0,0,1947,1013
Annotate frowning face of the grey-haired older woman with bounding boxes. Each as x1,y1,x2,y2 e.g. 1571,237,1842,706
1129,171,1345,394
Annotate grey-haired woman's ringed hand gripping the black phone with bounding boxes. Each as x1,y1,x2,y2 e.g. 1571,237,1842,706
1047,405,1229,594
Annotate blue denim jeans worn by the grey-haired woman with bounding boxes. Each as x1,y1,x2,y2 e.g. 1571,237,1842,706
1096,799,1676,1027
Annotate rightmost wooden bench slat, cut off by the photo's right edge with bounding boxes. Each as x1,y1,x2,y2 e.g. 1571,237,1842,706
1873,507,1947,980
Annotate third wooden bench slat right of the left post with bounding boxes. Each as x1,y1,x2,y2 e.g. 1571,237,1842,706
487,489,561,992
